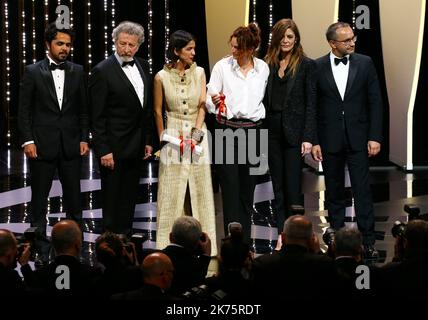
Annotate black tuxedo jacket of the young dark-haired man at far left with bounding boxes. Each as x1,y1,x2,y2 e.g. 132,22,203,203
18,58,89,160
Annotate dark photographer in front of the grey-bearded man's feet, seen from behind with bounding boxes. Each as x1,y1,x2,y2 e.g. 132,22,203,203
95,231,142,299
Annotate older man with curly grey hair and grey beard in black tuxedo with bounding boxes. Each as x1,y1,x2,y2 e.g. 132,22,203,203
89,21,153,235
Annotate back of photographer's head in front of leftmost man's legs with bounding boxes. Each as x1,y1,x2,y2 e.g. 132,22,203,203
52,220,82,257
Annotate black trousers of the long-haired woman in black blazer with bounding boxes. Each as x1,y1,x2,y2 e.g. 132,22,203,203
266,112,303,233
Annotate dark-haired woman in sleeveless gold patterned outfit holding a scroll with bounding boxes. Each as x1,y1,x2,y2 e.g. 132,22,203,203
154,30,217,255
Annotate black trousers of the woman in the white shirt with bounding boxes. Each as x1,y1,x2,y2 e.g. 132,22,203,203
215,122,260,242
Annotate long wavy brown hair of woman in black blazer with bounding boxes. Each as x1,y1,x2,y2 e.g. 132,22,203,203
265,19,305,76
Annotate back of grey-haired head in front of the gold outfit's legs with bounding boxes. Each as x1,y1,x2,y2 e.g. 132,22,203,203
171,216,202,250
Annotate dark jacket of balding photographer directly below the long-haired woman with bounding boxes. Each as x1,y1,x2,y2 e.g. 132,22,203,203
253,245,338,300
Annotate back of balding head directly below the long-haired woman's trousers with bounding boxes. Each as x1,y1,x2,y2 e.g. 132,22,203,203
283,215,314,247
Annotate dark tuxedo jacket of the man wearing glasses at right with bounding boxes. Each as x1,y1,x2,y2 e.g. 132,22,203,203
316,53,382,152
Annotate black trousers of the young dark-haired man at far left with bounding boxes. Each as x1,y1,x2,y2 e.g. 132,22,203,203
30,152,82,236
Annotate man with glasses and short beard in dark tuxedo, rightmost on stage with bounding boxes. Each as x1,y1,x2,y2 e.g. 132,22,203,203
312,22,382,256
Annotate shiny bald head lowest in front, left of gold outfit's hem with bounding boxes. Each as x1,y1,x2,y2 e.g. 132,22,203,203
142,252,174,289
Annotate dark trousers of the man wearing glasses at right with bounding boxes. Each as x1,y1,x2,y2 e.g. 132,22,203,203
321,138,376,245
